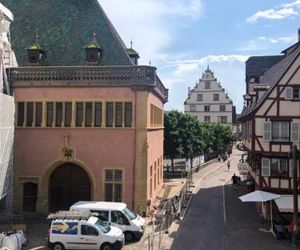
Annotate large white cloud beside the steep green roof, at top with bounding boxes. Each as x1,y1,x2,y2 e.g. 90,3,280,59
98,0,203,65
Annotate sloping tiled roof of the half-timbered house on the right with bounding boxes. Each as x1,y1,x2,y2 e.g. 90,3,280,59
239,46,300,119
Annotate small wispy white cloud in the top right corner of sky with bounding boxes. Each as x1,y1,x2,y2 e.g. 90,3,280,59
247,7,298,23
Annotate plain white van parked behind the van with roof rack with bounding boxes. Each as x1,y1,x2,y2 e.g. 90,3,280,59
70,201,145,242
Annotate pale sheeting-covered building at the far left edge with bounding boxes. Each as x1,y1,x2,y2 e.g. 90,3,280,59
0,3,17,213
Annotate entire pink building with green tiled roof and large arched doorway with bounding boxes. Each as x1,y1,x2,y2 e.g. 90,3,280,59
2,0,168,213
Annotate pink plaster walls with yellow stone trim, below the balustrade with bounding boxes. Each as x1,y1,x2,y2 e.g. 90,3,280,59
14,81,163,213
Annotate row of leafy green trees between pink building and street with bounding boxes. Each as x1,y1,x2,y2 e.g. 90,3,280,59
164,111,234,168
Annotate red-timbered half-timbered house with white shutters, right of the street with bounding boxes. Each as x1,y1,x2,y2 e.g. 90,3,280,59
239,34,300,199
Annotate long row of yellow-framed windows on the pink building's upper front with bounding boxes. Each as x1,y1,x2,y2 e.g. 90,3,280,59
15,99,133,128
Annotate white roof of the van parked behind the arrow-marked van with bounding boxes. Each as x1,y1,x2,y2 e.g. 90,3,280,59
70,201,127,211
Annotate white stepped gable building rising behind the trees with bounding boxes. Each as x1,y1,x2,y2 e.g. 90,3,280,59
184,67,233,128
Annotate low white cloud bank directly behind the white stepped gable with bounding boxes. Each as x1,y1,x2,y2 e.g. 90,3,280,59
160,54,249,112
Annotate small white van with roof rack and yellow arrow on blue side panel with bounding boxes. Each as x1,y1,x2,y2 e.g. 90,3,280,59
48,211,125,250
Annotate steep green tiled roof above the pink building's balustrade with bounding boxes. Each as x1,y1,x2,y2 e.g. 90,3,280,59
1,0,132,66
